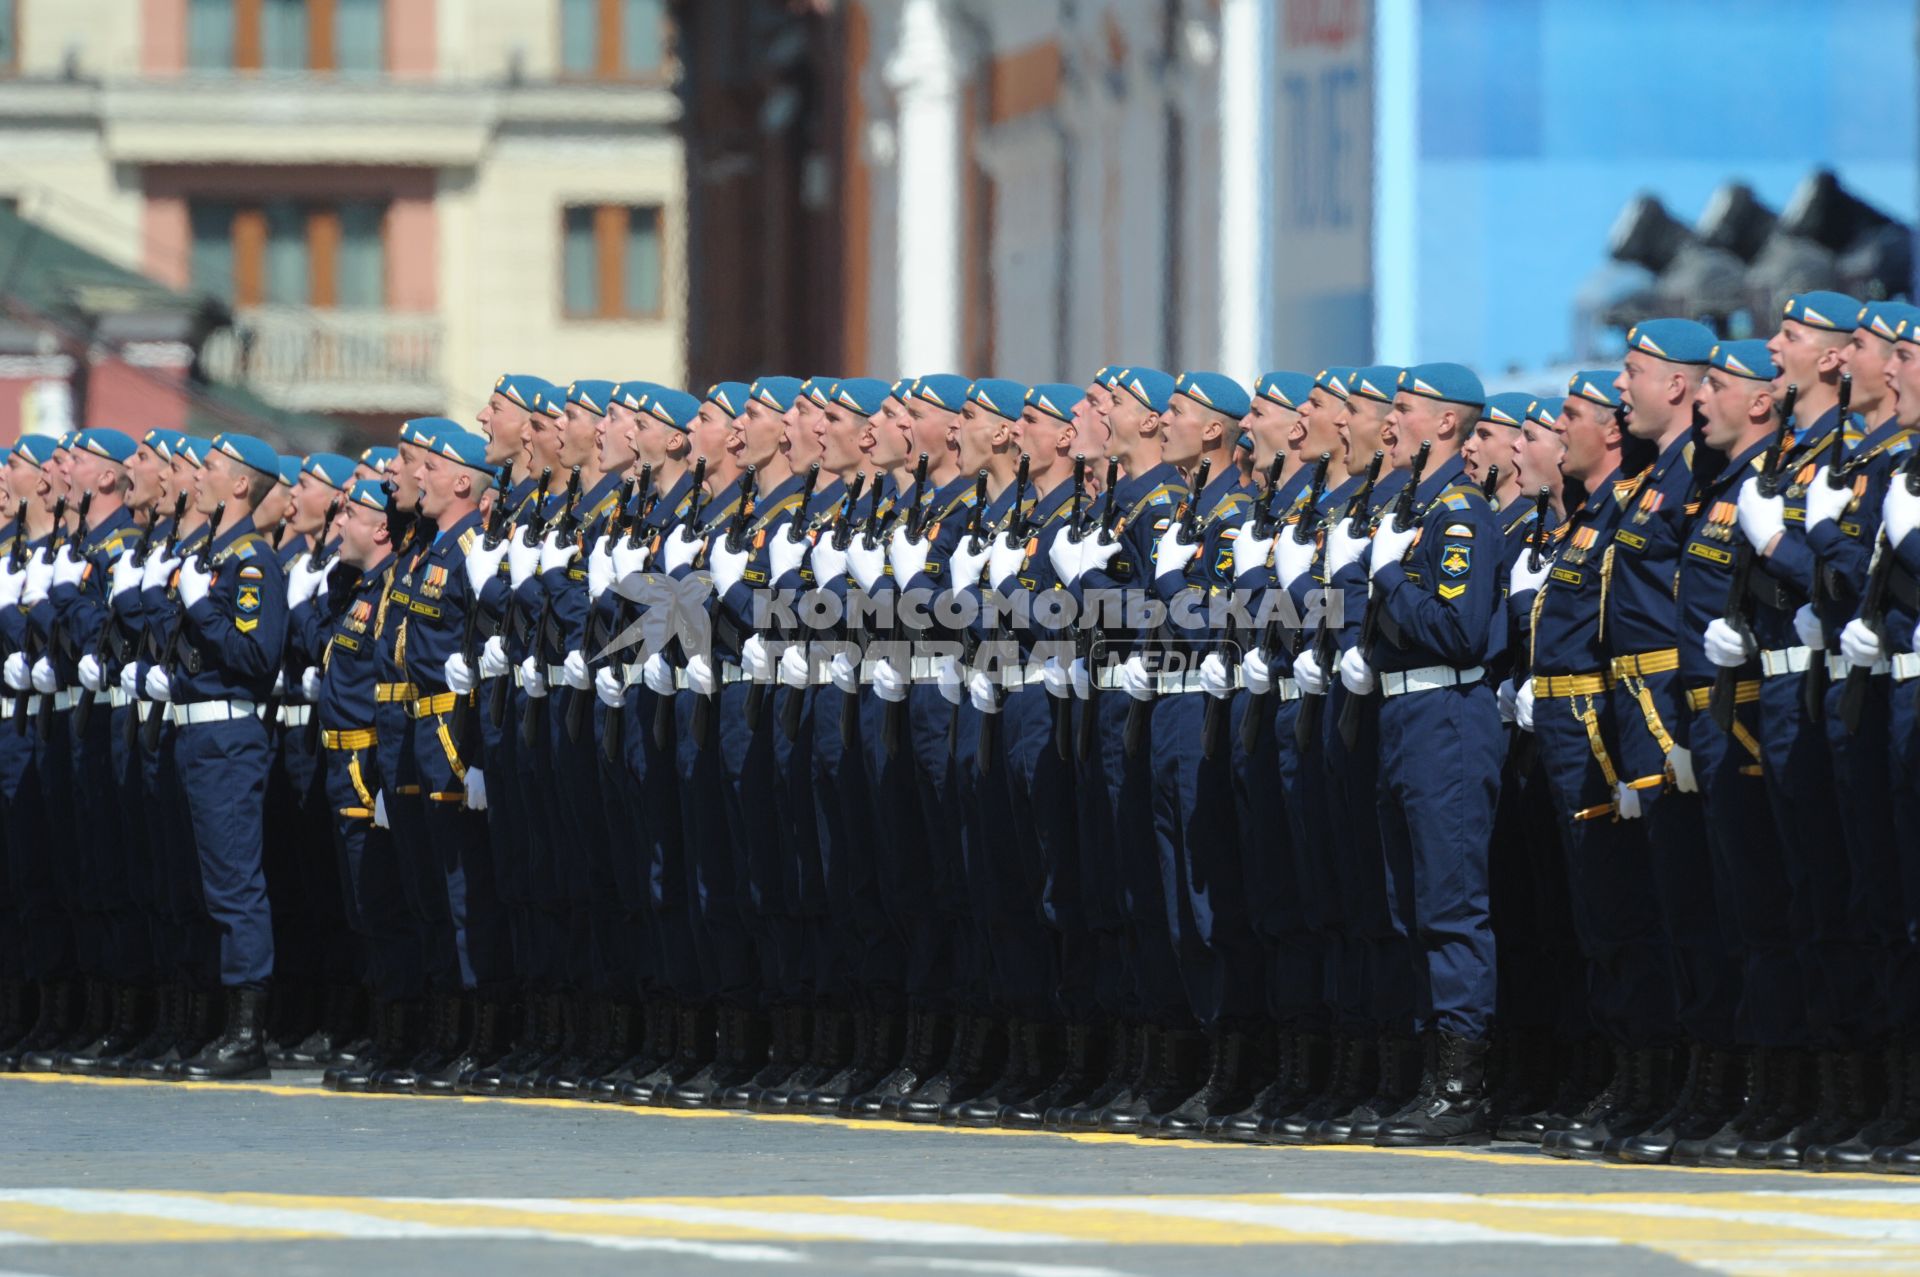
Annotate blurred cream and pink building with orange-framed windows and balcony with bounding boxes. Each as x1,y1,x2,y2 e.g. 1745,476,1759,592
0,0,687,443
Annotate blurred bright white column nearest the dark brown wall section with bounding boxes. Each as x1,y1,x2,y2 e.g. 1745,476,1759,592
885,0,966,376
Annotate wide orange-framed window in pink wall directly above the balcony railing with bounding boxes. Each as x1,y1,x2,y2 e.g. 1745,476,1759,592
188,200,386,309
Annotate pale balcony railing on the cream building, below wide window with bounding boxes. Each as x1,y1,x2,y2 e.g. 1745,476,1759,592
202,305,445,413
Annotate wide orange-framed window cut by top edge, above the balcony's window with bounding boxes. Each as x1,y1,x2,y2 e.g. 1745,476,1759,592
185,0,386,75
